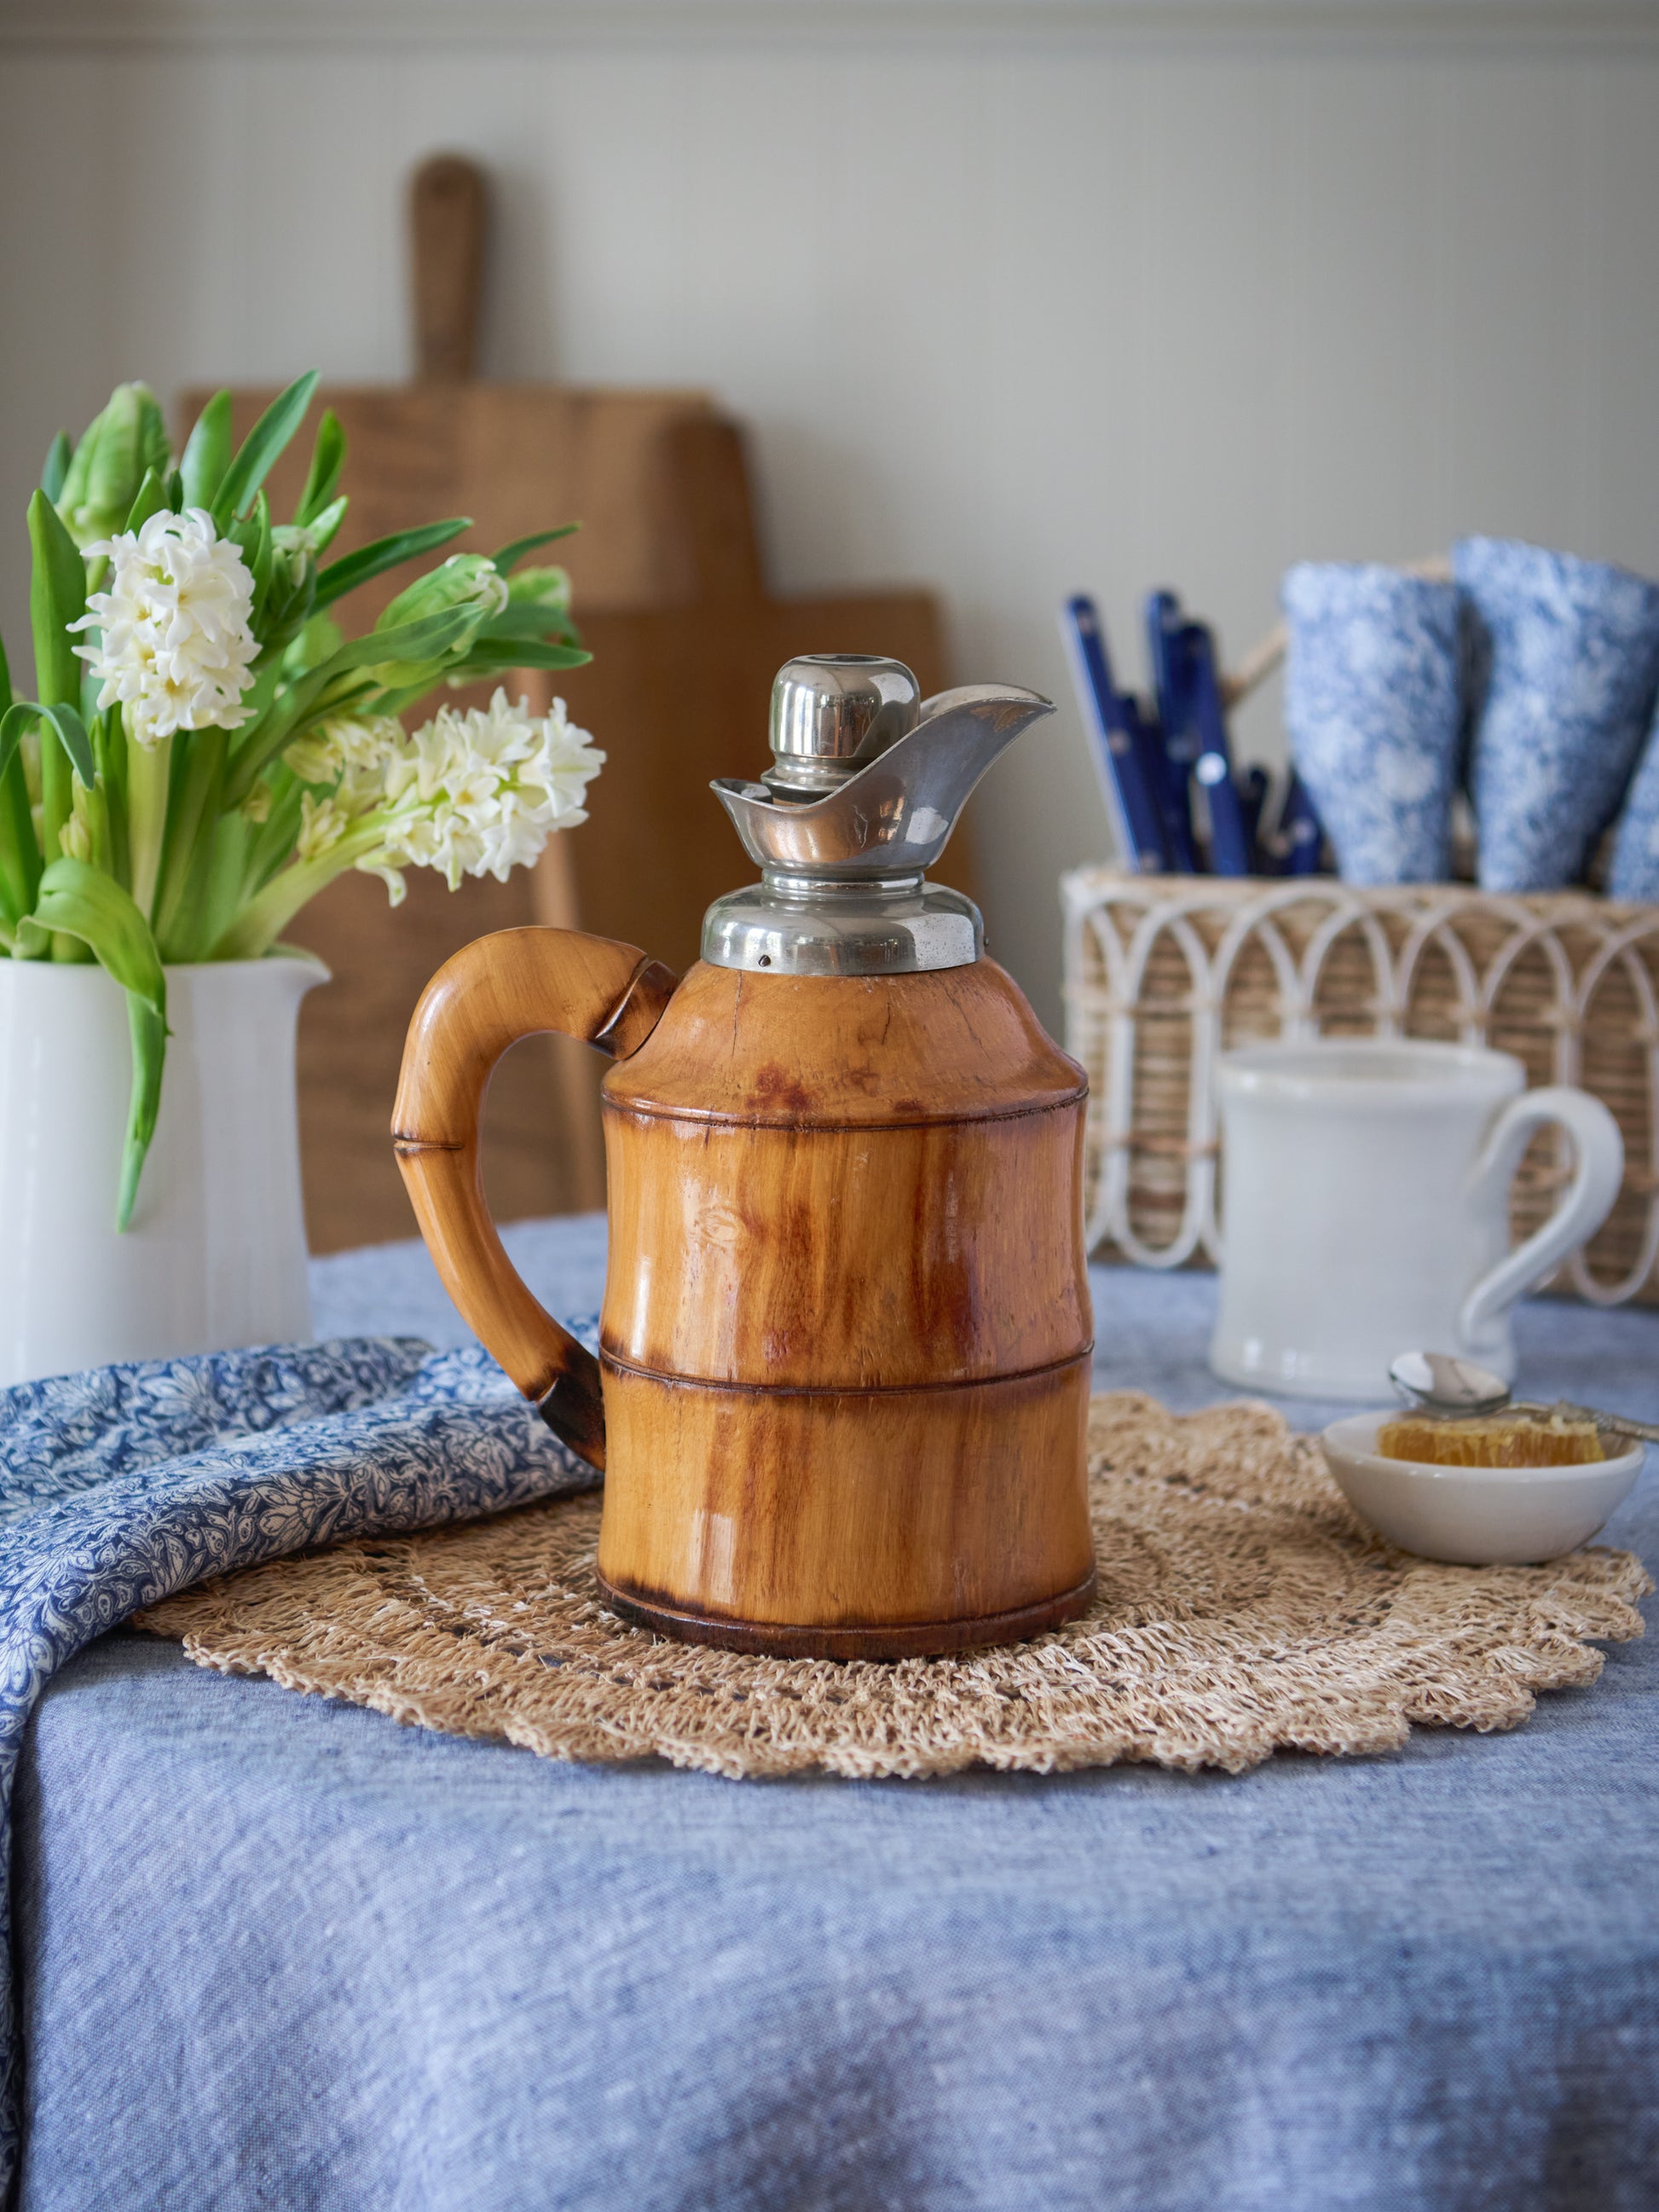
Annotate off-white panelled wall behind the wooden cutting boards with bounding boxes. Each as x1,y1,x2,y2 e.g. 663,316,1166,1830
0,0,1659,1020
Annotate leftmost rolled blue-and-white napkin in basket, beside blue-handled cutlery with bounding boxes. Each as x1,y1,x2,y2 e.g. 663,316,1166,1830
1283,562,1462,883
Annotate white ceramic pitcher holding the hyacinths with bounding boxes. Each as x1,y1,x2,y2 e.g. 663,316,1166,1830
0,956,327,1385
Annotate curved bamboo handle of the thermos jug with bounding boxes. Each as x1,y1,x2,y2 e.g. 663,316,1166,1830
391,929,679,1468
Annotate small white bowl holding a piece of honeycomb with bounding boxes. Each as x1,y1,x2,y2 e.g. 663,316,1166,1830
1321,1414,1648,1566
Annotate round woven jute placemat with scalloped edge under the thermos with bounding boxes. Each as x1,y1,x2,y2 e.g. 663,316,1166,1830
139,1393,1652,1776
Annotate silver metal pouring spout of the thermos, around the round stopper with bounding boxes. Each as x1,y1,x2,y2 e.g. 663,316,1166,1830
712,684,1053,883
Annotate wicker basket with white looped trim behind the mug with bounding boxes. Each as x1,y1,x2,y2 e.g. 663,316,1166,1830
1061,867,1659,1305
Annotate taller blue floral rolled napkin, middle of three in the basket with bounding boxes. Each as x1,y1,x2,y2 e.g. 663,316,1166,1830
1451,537,1659,896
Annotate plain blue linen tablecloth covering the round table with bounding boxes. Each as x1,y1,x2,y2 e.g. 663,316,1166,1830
15,1221,1659,2212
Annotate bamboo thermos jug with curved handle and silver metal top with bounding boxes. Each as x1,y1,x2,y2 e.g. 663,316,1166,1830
394,655,1095,1659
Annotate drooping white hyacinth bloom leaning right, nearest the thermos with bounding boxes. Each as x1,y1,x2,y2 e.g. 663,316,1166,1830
376,690,604,891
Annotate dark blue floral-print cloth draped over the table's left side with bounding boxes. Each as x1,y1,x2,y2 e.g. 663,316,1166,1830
0,1327,599,2201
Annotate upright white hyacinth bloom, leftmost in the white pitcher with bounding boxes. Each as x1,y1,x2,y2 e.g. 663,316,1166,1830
71,507,259,745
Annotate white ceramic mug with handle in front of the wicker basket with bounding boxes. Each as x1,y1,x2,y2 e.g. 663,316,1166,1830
1210,1038,1623,1400
